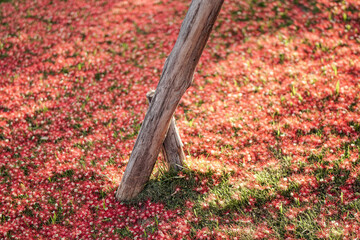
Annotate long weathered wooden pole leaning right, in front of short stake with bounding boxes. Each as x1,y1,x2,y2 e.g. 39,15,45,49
116,0,224,201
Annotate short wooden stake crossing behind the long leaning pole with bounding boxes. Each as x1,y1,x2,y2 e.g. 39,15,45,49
146,90,185,171
